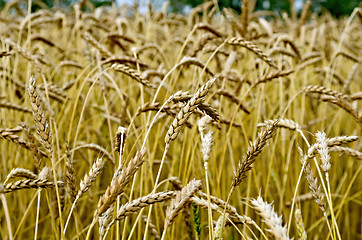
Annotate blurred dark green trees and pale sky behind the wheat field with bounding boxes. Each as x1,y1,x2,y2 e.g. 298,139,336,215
0,0,362,18
